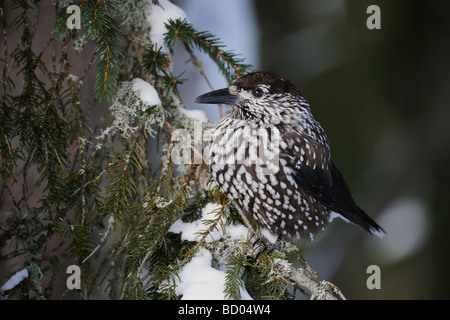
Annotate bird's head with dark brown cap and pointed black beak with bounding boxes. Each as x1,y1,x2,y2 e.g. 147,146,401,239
195,72,309,124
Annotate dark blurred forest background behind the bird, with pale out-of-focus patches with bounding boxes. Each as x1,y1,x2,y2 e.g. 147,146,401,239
175,0,450,299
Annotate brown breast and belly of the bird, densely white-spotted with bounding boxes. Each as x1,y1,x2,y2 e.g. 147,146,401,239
209,121,328,238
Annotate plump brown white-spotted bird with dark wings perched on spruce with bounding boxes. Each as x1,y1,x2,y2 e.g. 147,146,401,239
195,71,385,241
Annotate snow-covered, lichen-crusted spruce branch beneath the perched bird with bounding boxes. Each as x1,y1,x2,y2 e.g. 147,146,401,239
164,186,345,300
